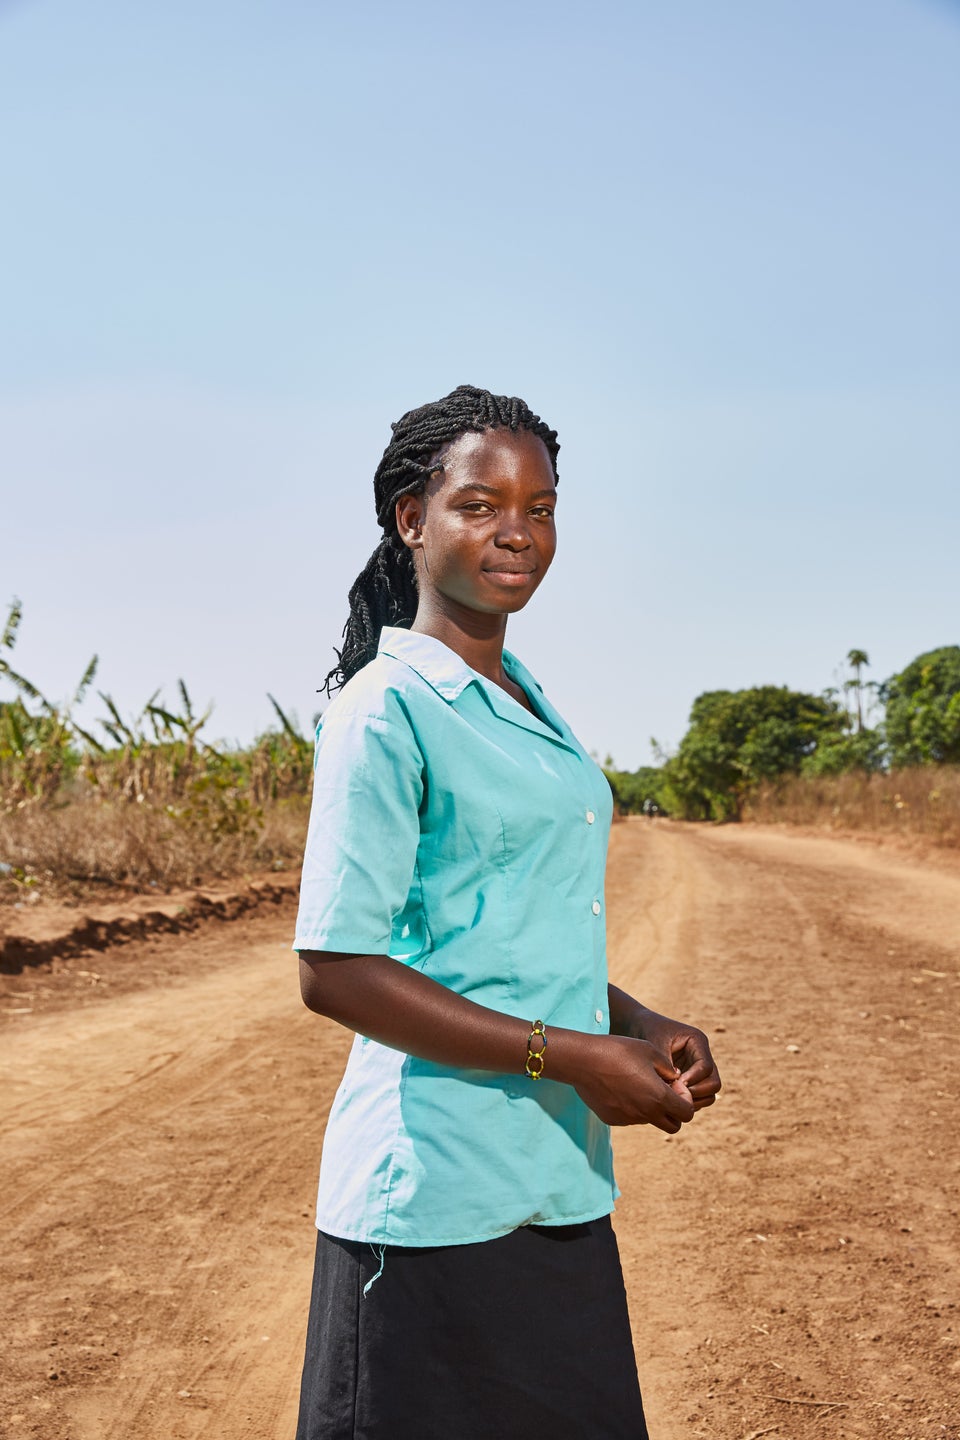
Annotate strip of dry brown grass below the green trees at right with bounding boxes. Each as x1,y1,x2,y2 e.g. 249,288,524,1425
744,765,960,847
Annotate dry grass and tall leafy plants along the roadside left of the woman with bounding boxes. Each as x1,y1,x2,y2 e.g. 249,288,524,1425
0,600,314,904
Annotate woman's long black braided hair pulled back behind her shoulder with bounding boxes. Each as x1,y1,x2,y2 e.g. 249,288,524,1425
324,384,560,696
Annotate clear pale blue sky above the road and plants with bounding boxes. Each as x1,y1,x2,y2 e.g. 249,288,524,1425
0,0,960,768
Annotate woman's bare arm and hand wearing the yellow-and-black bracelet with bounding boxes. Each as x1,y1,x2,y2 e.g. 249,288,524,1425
299,950,694,1135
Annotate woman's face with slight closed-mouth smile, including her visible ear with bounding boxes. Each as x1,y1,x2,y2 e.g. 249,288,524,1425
397,428,557,615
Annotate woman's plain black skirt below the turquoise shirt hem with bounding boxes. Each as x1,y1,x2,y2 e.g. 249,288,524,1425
296,1215,648,1440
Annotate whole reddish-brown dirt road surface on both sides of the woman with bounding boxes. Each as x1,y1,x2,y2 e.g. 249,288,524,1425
0,821,960,1440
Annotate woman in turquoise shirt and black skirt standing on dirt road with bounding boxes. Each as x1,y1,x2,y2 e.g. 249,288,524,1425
295,386,720,1440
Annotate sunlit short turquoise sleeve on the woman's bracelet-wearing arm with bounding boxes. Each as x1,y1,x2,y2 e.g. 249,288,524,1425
294,707,423,955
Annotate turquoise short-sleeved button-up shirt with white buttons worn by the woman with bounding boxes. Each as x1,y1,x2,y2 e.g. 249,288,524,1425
294,628,617,1246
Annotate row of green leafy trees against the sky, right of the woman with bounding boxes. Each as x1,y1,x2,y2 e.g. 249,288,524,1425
604,645,960,821
